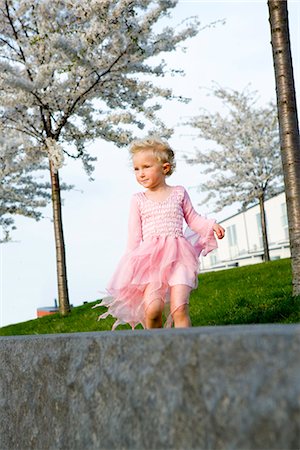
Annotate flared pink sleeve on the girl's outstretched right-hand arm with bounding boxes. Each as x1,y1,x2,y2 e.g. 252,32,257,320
183,191,218,256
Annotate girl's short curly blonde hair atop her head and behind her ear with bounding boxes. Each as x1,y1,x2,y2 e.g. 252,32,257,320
129,136,176,177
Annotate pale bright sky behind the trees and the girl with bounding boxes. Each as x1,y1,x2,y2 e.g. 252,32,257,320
0,0,300,326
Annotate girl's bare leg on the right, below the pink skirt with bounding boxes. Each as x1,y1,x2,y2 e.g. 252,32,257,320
170,284,192,328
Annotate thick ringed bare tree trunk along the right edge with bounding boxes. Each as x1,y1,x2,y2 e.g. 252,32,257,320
268,0,300,296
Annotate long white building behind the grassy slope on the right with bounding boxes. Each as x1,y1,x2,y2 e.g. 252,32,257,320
201,192,290,272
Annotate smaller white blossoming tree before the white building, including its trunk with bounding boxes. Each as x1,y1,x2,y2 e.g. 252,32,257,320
186,87,282,261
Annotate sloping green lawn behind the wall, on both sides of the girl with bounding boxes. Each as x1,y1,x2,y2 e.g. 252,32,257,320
0,259,300,336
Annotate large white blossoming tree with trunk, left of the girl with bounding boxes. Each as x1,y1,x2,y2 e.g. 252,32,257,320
0,0,197,314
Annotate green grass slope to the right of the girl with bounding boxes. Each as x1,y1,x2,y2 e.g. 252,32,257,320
190,259,300,326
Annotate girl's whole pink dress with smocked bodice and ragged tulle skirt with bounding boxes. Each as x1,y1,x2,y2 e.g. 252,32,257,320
97,186,217,329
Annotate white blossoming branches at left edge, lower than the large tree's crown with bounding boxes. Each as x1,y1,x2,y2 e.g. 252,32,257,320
0,134,51,243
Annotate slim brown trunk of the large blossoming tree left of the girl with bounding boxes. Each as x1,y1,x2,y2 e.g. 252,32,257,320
50,161,70,315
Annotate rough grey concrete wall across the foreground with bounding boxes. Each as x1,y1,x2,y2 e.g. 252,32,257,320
0,325,300,450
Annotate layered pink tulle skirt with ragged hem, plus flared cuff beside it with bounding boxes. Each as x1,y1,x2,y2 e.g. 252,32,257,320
96,229,217,329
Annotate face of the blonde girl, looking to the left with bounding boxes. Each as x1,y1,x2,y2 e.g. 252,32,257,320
132,150,170,190
